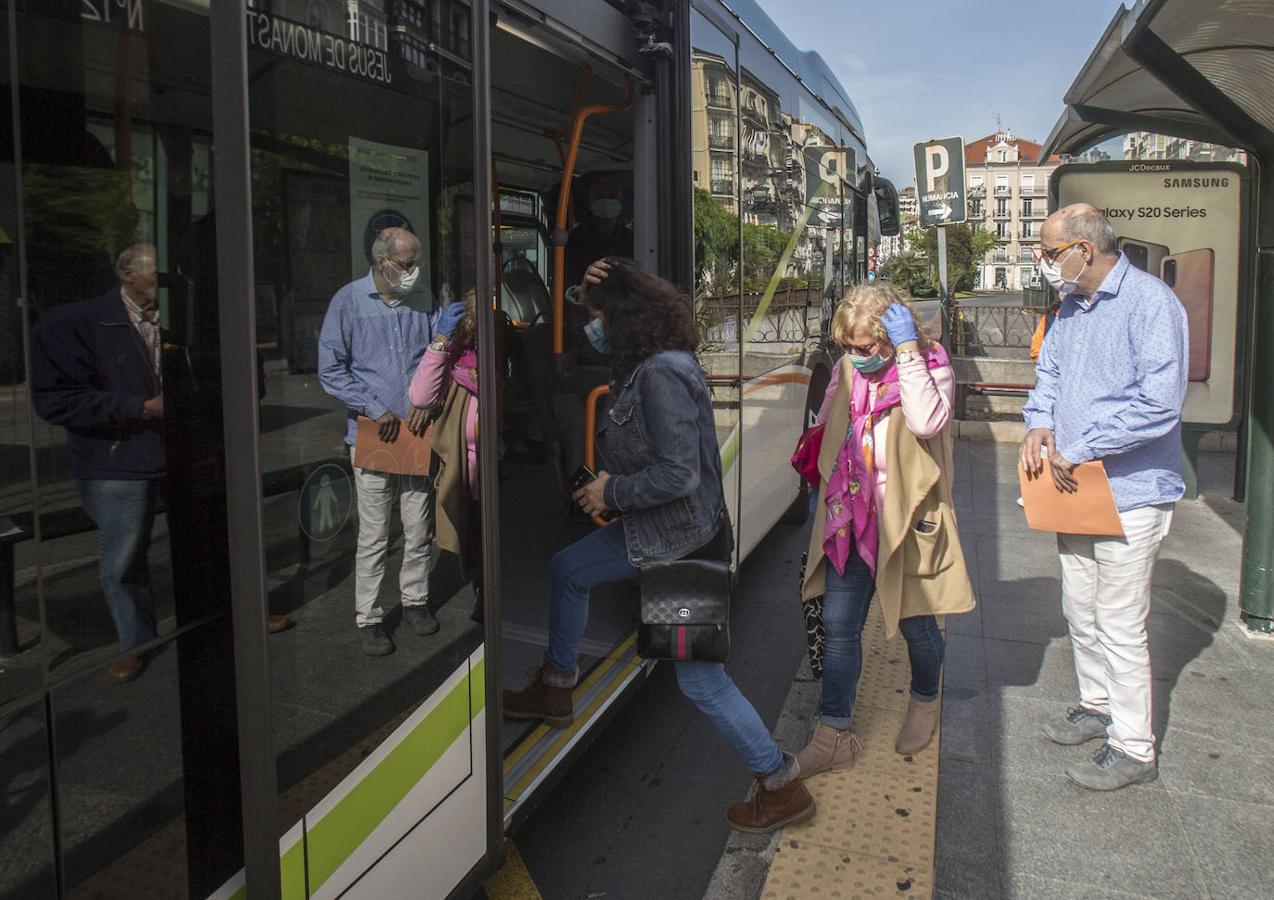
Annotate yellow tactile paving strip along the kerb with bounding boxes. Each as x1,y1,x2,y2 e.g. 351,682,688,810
762,607,940,900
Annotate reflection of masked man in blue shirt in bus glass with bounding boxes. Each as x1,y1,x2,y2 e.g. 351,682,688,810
319,228,438,657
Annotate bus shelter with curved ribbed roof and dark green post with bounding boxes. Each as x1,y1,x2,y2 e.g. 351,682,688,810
1043,0,1274,635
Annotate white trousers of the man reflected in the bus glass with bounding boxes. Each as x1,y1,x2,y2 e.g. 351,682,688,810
349,447,433,627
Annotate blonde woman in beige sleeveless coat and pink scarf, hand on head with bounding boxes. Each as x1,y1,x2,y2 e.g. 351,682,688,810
798,284,973,776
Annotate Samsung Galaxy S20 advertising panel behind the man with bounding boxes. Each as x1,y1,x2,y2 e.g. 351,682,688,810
1051,161,1250,427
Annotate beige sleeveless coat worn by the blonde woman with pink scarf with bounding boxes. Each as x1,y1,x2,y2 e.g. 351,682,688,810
801,361,975,637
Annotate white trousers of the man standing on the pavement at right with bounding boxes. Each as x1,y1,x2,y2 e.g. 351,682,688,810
1057,504,1172,762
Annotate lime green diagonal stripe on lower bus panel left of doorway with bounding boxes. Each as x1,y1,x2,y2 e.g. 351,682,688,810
303,657,478,896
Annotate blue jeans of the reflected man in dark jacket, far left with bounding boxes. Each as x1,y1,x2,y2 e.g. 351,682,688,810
76,478,159,653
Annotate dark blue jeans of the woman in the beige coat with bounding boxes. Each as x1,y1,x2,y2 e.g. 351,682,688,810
819,551,945,732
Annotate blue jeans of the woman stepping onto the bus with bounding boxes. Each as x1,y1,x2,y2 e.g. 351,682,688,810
544,521,784,775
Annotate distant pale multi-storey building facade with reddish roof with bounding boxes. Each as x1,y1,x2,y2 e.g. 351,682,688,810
964,130,1061,291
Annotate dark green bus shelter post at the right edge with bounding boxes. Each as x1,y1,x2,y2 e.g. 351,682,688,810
1240,164,1274,635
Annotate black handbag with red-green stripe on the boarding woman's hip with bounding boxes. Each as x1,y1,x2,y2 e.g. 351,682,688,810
637,560,733,663
